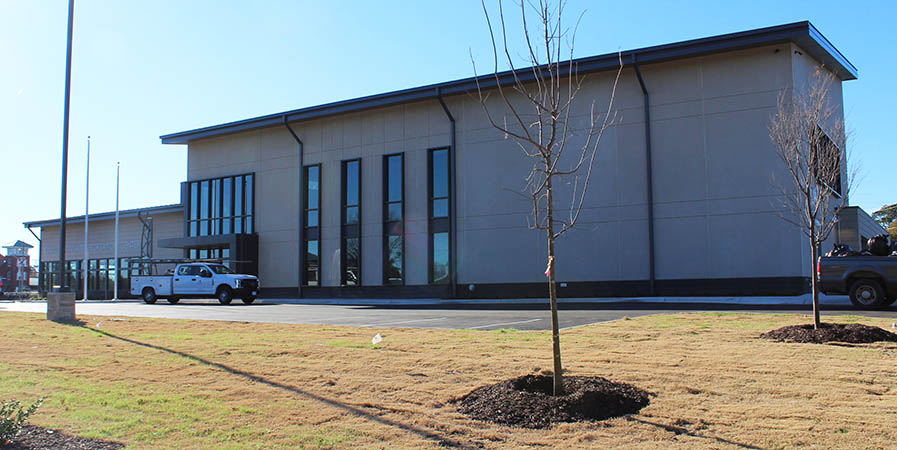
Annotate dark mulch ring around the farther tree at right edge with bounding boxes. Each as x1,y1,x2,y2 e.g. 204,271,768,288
760,323,897,344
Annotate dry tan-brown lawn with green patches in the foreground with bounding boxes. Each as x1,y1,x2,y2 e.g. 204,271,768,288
0,313,897,449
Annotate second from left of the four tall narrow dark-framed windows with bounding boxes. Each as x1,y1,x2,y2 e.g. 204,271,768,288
340,159,361,286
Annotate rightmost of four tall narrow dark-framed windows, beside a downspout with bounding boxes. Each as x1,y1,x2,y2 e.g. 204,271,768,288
427,148,451,284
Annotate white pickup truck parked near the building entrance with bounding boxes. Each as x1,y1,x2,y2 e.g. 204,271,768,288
131,262,259,305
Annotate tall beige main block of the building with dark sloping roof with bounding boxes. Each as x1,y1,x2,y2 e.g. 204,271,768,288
28,22,876,298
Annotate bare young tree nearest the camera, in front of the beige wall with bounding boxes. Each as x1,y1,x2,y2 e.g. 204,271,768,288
474,0,622,395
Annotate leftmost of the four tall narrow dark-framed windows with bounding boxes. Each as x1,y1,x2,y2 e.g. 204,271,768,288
302,164,321,286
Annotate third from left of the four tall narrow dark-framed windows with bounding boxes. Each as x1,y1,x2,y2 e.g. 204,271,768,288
383,153,405,284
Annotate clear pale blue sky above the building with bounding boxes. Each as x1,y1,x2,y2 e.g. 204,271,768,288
0,0,897,255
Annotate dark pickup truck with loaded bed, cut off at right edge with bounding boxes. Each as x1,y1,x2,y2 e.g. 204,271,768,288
816,256,897,309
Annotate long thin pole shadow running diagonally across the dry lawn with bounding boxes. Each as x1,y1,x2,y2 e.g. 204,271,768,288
84,322,476,449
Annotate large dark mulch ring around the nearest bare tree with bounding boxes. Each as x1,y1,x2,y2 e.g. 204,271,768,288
455,375,650,428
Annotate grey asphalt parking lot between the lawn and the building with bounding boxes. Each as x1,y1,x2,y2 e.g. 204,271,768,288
0,300,897,330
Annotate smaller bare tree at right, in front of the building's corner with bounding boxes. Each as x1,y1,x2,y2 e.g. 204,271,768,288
769,68,855,329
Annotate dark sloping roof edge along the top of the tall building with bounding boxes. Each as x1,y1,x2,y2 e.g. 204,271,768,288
160,21,857,144
